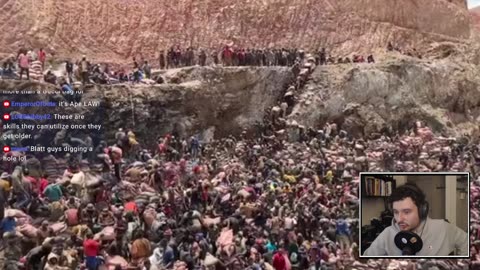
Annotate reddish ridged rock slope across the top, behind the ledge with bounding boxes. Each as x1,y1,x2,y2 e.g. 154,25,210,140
0,0,470,62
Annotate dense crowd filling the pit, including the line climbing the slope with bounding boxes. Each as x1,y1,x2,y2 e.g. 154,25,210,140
0,42,474,270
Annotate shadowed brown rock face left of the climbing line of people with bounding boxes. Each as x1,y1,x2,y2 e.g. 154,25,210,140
0,67,293,148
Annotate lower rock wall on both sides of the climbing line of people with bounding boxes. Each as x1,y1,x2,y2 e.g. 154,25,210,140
0,49,480,149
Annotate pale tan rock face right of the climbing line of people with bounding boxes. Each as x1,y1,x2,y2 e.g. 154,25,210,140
290,51,480,136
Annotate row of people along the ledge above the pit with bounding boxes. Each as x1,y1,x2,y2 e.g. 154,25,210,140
0,45,375,88
